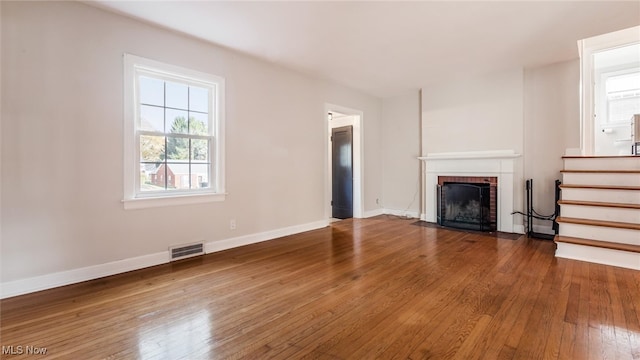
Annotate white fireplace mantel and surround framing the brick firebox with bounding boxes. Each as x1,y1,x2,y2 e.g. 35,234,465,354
418,150,521,233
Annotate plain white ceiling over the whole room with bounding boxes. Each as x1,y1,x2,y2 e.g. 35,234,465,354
87,1,640,97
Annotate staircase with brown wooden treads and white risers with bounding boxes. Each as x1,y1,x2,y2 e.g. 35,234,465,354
555,156,640,270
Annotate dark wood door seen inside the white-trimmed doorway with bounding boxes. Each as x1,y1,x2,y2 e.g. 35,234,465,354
331,126,353,219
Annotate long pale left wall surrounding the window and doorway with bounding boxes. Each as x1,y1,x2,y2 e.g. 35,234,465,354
0,2,382,292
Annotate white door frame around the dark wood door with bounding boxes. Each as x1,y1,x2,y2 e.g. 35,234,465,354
322,103,364,220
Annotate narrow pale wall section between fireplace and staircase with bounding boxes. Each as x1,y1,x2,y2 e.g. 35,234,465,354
524,59,580,231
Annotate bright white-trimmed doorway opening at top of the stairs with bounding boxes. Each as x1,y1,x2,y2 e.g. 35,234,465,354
578,26,640,156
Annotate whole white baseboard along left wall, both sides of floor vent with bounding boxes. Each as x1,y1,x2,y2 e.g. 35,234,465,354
0,220,329,299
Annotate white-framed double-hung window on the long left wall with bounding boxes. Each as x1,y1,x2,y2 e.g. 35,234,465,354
124,54,224,208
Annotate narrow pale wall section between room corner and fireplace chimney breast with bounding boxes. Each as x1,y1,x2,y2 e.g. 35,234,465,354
380,90,421,217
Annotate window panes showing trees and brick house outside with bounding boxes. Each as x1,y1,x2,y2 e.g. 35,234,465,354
138,76,213,191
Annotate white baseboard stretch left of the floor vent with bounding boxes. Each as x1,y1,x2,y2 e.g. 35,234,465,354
0,250,170,299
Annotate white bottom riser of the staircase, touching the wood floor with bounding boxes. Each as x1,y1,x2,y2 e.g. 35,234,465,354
556,243,640,270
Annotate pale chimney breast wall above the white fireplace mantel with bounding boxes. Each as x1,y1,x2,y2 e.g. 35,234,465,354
422,69,524,225
